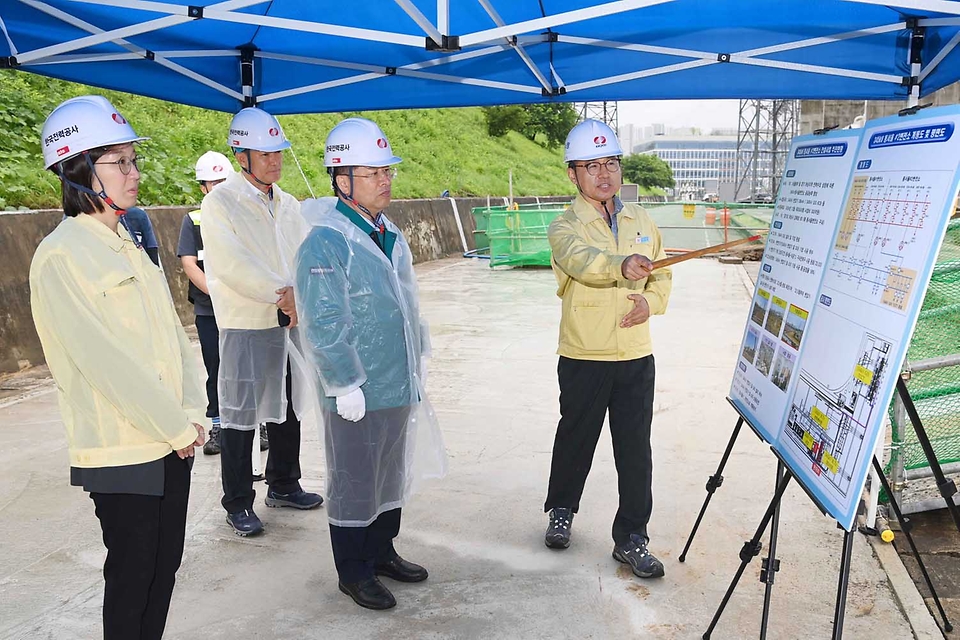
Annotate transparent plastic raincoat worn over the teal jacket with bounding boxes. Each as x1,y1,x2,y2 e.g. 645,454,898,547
295,198,447,527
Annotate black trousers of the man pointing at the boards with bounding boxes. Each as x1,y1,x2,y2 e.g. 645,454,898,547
543,355,656,545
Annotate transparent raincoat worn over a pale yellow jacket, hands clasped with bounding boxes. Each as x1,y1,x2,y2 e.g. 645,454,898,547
201,173,309,431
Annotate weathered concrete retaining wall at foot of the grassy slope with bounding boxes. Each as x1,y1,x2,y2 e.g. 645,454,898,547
0,196,570,375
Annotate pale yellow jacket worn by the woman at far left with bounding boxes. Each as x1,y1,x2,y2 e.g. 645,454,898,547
30,214,209,467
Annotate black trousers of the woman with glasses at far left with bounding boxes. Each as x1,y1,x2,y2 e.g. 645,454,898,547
90,453,190,640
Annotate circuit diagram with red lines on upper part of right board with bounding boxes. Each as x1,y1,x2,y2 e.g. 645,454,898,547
829,171,935,311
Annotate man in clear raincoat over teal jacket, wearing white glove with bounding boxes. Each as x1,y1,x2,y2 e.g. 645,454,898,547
296,118,446,609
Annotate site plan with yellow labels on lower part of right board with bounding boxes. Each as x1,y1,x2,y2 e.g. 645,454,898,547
781,333,892,497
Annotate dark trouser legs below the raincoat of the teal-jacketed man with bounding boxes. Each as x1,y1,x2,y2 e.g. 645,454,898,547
328,510,400,584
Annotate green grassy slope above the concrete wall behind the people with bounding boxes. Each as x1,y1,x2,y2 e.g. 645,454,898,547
0,72,573,209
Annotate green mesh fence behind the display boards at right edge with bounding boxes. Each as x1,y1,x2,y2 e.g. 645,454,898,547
888,220,960,482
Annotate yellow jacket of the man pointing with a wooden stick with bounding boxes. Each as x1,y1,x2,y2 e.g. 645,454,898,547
549,196,673,361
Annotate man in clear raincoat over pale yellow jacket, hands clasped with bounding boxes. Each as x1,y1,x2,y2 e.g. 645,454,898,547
200,108,323,536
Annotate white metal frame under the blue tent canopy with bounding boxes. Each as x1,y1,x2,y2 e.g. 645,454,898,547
0,0,960,110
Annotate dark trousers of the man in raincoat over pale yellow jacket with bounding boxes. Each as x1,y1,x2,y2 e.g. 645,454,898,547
220,365,300,513
